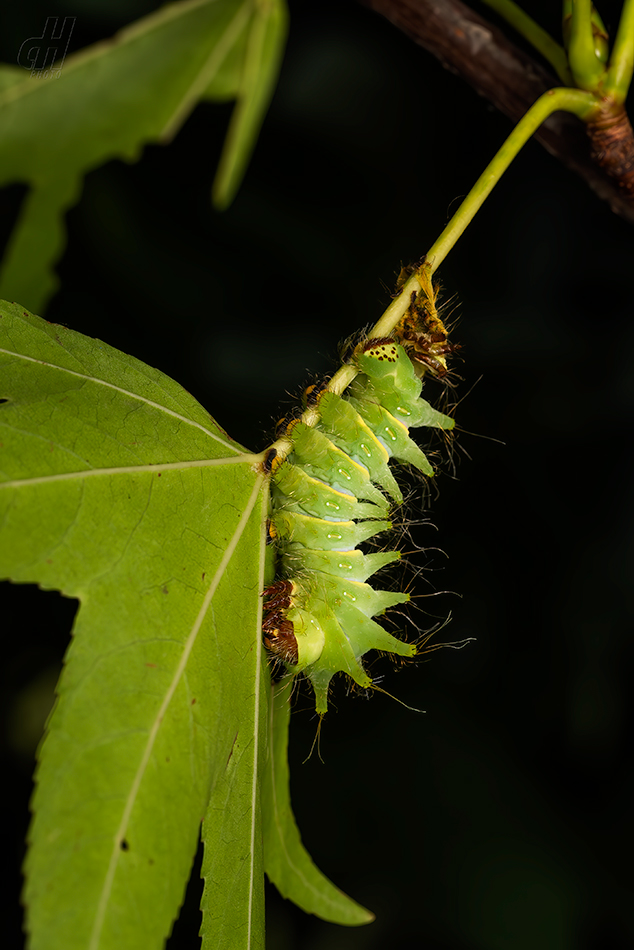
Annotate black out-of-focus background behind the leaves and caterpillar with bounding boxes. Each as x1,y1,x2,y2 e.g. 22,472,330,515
0,0,634,950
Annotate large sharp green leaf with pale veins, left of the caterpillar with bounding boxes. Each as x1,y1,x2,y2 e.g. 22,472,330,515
0,304,268,950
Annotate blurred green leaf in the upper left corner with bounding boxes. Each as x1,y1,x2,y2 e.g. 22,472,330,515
0,0,285,309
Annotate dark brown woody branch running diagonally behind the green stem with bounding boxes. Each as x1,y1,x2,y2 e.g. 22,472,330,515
360,0,634,224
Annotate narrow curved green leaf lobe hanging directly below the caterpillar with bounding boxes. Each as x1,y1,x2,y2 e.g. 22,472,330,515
262,680,374,926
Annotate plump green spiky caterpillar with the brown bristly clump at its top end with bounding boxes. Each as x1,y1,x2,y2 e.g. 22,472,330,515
262,282,455,715
